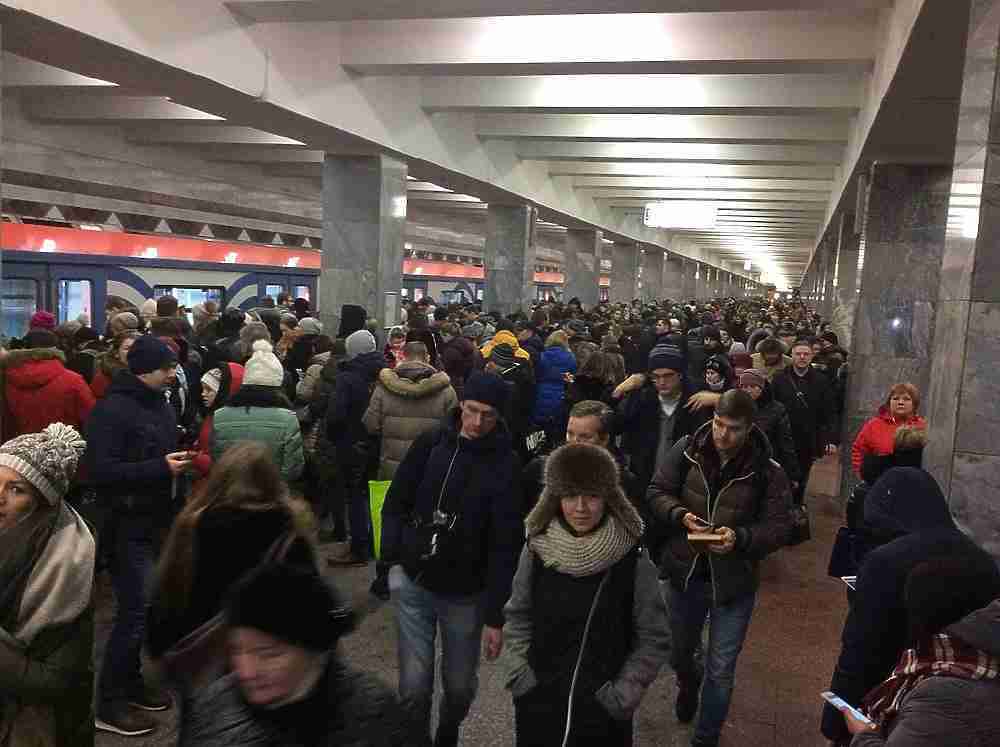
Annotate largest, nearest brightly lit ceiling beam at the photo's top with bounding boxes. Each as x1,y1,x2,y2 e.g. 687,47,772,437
341,11,879,76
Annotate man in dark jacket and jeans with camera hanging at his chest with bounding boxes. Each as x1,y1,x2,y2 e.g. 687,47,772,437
382,373,524,747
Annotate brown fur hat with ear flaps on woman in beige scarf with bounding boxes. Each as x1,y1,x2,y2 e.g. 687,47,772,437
524,444,643,541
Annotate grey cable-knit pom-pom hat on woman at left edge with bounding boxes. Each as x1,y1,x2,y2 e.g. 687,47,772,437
0,423,87,506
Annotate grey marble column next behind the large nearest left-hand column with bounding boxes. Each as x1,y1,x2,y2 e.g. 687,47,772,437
483,204,536,315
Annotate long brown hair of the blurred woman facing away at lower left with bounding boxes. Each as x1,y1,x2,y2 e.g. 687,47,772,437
157,441,313,612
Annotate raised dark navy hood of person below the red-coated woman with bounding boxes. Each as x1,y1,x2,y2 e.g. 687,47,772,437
865,467,955,535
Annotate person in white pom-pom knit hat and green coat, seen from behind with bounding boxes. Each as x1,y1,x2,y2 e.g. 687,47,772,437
212,340,304,482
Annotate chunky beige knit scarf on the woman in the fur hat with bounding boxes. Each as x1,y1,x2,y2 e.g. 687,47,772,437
528,513,639,578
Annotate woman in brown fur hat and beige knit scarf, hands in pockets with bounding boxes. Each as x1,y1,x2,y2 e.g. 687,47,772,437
503,443,669,747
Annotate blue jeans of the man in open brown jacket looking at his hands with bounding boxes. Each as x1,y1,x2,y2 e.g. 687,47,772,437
669,579,757,746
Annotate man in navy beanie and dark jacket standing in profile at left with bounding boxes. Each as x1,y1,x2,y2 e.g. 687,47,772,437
86,336,190,736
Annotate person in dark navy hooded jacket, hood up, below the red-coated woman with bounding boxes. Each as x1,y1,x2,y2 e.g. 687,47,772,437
822,467,989,740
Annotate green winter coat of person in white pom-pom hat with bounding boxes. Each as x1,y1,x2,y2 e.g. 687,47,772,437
212,406,304,482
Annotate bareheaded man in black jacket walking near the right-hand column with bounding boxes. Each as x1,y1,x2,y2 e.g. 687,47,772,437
771,339,839,506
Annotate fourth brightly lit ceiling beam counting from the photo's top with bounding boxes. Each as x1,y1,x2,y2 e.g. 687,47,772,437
517,140,844,166
